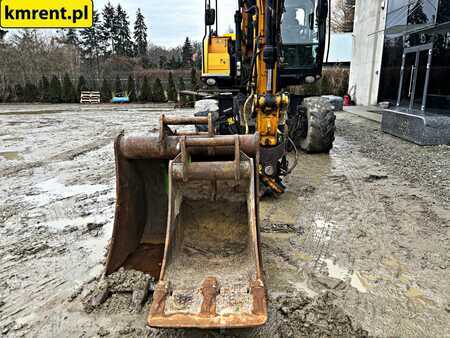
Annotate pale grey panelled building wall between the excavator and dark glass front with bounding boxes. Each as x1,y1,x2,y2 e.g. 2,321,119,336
349,0,387,105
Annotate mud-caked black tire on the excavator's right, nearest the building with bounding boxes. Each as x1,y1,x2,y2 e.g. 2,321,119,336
295,97,336,154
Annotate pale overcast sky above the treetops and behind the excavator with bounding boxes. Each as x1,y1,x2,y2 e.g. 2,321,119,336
94,0,238,47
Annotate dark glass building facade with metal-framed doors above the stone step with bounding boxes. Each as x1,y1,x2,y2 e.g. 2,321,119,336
378,0,450,114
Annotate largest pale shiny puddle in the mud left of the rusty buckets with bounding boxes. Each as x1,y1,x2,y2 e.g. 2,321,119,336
26,178,109,206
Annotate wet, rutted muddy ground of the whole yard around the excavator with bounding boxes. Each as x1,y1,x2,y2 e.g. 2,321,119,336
0,105,450,337
